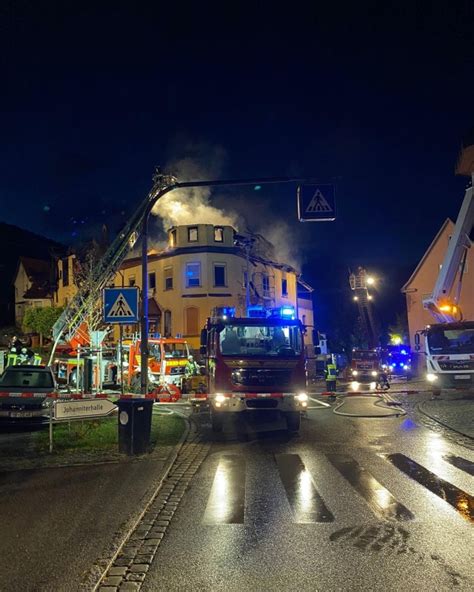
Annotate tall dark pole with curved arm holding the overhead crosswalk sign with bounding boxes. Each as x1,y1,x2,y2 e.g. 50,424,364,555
140,168,315,395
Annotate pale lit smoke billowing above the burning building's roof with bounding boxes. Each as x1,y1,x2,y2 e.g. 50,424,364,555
152,144,239,231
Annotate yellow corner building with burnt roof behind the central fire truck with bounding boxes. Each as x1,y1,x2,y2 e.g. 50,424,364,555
115,224,313,349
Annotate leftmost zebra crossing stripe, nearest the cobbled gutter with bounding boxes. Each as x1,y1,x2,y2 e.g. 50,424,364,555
202,454,246,524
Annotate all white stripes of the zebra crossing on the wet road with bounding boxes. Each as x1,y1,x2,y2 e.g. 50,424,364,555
202,452,474,525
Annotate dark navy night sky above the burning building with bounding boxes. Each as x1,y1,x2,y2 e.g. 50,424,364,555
0,1,474,327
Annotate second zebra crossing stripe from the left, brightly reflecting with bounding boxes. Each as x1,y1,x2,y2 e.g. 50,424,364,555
275,454,334,524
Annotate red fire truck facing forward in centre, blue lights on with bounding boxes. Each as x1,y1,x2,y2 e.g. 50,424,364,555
200,307,308,432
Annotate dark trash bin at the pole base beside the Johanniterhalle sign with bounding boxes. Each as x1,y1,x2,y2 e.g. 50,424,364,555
118,399,153,455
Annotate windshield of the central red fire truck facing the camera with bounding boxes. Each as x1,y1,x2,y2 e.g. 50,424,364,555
219,325,302,358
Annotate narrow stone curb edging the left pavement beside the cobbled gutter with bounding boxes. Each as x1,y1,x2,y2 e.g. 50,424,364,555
81,414,191,592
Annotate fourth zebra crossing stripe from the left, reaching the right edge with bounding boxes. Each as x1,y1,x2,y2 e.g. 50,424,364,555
385,453,474,522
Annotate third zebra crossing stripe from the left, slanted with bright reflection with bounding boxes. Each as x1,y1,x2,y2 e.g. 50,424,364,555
326,454,414,521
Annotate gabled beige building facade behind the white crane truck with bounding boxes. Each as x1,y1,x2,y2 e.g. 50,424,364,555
402,218,474,348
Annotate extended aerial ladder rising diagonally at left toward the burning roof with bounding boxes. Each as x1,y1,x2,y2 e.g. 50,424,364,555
49,169,177,364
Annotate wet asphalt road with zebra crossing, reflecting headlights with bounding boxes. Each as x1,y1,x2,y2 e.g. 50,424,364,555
142,400,474,592
